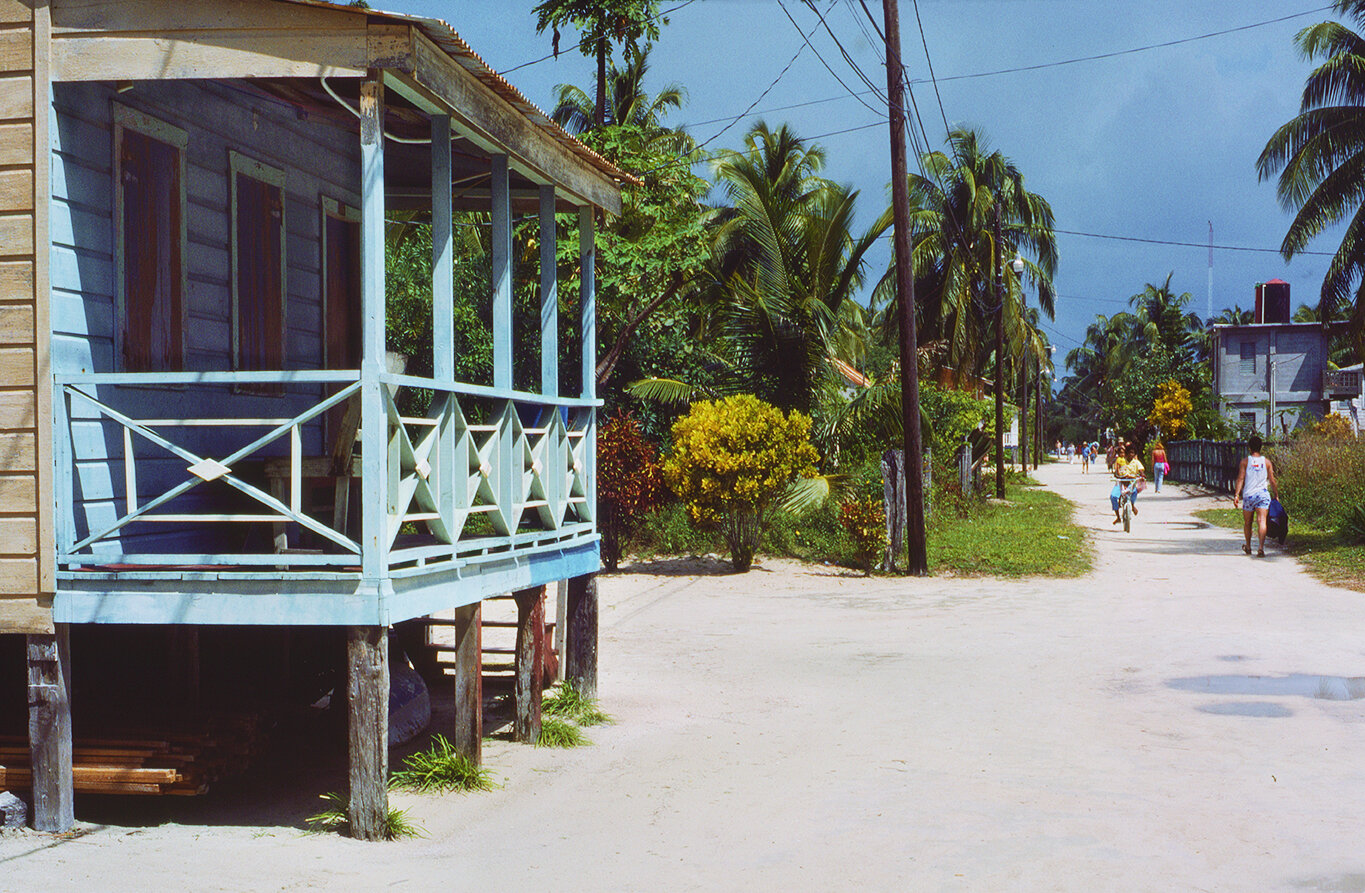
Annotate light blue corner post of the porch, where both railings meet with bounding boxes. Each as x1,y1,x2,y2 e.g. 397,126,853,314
360,71,389,587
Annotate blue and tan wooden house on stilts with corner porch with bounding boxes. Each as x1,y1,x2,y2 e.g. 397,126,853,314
0,0,622,837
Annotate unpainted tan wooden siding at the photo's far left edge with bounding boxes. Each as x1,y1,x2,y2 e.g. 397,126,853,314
0,0,52,632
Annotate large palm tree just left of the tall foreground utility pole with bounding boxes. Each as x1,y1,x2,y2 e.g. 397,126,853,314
632,122,890,420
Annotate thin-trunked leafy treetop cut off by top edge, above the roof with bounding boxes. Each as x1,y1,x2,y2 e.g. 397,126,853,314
532,0,667,127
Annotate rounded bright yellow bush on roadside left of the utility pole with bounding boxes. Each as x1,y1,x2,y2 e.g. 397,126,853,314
663,395,819,572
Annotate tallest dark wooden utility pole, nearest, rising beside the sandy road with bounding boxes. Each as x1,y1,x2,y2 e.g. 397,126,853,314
882,0,930,576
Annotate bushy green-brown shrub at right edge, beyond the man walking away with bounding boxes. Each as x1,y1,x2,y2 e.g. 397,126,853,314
1271,434,1365,530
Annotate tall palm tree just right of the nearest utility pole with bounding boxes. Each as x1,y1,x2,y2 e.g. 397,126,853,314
909,128,1057,374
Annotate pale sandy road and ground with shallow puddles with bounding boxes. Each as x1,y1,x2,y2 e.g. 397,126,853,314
0,464,1365,892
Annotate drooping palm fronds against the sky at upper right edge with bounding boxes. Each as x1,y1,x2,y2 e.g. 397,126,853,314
1256,0,1365,341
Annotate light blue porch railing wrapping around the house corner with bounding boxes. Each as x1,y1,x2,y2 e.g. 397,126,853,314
53,371,598,576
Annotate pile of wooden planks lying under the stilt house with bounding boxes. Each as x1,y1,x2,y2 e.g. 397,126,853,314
0,717,261,796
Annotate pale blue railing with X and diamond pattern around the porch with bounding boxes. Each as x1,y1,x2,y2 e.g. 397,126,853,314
55,373,597,569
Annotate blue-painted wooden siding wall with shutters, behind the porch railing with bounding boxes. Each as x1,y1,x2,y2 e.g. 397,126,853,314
52,81,359,552
